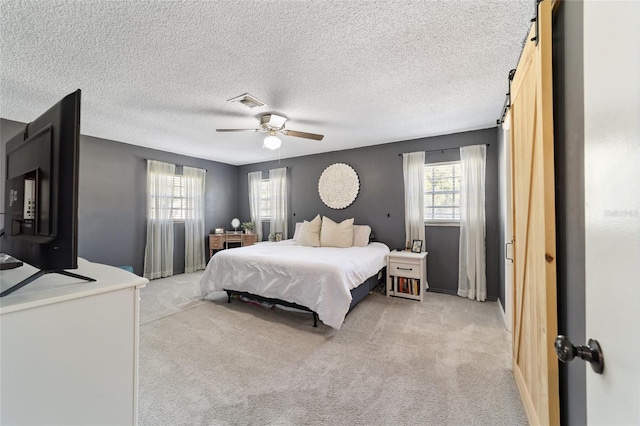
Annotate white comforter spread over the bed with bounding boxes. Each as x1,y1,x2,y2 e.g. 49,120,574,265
200,240,389,329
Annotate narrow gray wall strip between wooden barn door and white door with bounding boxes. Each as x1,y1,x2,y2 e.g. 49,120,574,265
553,2,587,425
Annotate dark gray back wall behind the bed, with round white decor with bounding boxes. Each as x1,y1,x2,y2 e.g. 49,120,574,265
238,128,499,300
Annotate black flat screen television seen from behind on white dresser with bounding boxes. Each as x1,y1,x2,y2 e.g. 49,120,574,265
0,90,94,297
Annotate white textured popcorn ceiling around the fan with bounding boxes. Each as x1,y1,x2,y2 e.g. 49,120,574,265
0,0,535,165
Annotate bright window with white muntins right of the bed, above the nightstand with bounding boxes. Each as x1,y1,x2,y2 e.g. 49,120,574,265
424,161,462,224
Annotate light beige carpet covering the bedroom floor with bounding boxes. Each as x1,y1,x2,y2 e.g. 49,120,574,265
139,273,527,425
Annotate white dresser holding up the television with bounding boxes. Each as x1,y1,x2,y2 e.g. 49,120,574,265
0,259,148,425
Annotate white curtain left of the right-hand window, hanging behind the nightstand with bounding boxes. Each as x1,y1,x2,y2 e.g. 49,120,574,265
402,151,427,251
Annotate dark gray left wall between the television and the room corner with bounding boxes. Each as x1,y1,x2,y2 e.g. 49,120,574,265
0,119,238,275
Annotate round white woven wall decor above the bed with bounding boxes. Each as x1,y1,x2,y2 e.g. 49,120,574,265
318,163,360,209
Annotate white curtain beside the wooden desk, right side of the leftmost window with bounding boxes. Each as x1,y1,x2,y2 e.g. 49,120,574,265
182,166,207,273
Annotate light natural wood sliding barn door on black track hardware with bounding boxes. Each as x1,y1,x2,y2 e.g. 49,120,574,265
510,1,560,425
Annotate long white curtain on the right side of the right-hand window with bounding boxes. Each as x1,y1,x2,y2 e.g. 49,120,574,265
458,145,487,301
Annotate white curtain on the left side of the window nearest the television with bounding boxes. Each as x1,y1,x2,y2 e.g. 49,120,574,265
144,160,176,279
